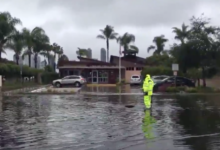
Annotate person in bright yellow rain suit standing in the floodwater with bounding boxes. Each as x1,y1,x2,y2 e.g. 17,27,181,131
143,74,154,109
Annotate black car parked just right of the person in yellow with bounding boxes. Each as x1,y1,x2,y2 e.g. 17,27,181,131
154,76,195,92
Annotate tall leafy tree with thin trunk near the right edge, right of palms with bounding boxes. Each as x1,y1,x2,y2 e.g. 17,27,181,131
189,14,219,87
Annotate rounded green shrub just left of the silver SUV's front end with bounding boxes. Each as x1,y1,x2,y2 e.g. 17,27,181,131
41,72,59,84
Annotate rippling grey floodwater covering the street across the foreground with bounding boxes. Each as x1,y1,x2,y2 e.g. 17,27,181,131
0,88,220,150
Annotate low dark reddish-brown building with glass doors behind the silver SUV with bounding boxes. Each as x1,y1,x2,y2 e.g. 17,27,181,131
58,57,125,84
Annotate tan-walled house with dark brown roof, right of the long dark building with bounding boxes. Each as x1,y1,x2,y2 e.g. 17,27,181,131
110,55,146,82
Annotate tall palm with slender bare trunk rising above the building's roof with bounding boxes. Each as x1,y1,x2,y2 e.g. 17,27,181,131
97,25,118,62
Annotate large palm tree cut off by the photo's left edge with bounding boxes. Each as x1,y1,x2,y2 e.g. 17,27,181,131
0,12,21,61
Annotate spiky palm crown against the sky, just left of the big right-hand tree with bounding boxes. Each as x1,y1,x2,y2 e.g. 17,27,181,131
173,23,191,44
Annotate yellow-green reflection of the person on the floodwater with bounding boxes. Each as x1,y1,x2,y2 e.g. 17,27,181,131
142,110,156,139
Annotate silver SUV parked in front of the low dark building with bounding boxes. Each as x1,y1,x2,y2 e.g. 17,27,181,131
52,75,86,87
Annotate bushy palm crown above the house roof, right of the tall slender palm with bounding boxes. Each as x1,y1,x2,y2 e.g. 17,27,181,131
117,32,139,55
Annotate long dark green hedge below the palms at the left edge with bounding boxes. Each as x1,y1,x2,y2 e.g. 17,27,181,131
0,63,43,78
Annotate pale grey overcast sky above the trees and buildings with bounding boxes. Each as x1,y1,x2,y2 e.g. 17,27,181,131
0,0,220,60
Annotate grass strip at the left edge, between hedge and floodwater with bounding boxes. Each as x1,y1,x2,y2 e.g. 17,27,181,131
2,82,41,91
